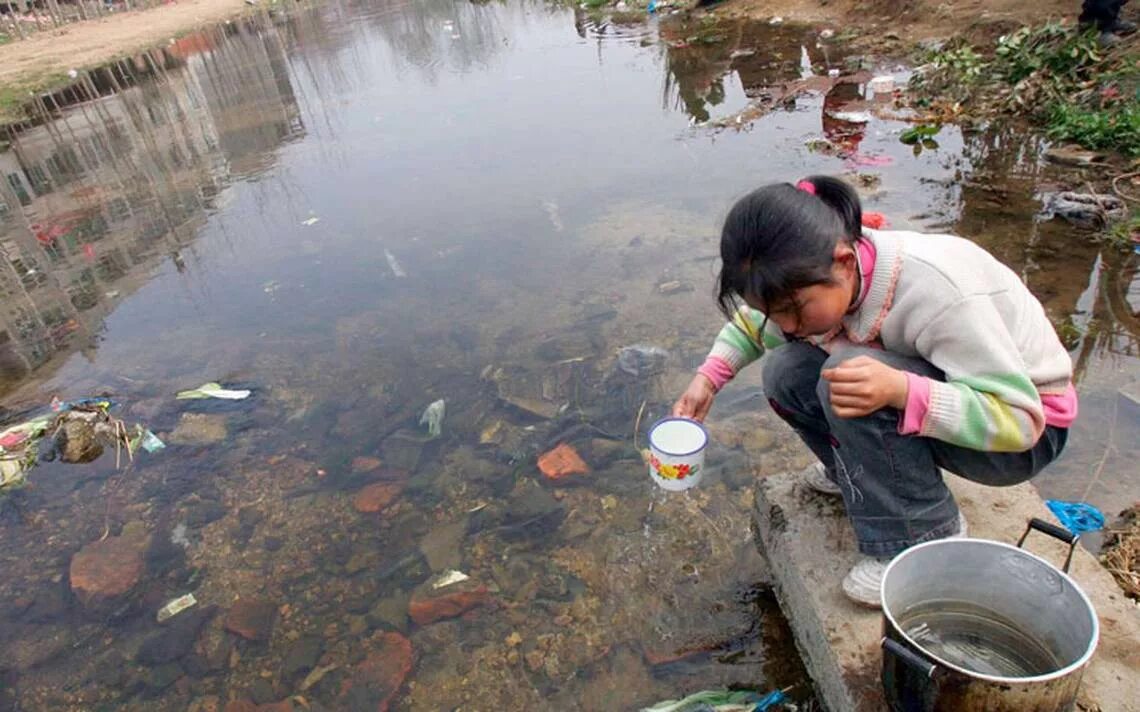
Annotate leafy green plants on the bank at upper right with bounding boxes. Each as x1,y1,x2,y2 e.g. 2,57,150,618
911,23,1140,157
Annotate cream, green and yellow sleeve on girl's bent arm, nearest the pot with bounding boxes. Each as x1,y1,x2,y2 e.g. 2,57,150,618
915,295,1045,452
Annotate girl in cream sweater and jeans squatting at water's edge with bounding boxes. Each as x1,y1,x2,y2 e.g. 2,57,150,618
673,177,1077,607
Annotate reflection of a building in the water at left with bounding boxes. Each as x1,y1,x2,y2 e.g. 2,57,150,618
0,11,304,390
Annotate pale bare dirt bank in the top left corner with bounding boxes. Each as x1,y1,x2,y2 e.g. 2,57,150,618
0,0,273,90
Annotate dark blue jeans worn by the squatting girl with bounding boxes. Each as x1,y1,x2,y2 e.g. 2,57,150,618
763,342,1068,558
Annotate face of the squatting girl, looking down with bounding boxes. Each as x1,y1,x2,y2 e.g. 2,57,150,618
746,242,860,338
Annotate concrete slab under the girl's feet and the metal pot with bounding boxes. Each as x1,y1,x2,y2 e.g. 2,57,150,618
754,474,1140,712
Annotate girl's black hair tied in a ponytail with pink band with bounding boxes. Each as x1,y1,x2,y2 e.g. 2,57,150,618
716,175,863,320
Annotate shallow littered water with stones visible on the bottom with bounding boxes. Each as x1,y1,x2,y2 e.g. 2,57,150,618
0,0,1140,710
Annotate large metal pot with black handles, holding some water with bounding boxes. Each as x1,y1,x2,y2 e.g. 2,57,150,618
882,519,1099,712
